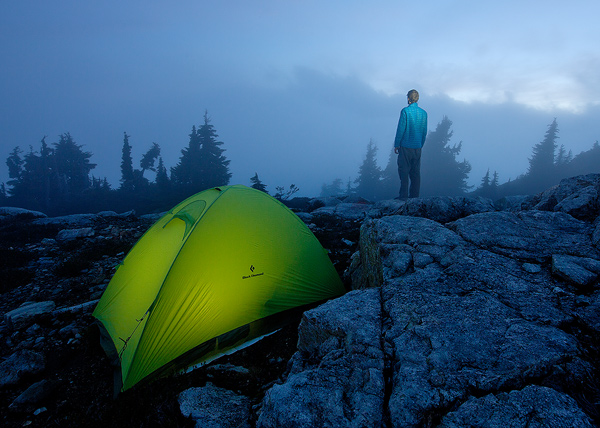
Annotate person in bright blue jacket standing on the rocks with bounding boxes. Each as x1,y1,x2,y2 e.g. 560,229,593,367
394,89,427,200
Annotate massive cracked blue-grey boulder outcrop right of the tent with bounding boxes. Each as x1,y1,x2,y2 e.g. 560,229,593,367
258,200,600,427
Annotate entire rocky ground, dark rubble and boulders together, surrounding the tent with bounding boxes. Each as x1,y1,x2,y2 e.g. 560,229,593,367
0,175,600,428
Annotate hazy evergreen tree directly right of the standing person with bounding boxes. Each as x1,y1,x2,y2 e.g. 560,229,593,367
421,116,471,196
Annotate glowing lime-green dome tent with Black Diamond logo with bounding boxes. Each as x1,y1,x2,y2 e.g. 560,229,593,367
93,185,344,391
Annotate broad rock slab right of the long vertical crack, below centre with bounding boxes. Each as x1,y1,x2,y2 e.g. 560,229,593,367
383,279,579,427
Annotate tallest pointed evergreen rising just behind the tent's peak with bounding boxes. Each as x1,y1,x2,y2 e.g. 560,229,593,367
198,112,231,189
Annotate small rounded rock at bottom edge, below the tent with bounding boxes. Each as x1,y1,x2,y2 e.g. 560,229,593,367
178,382,250,428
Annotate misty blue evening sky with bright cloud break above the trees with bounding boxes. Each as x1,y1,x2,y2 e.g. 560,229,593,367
0,0,600,196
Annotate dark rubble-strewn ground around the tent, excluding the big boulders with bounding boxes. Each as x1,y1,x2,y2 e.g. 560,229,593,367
0,205,360,428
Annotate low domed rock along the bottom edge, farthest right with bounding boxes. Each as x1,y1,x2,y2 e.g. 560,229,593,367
439,386,594,428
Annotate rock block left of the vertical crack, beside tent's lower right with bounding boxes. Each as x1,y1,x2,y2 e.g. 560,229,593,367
256,289,385,428
